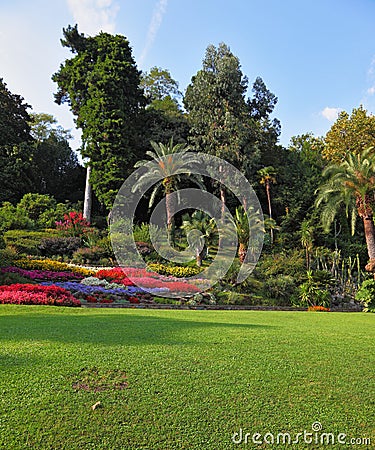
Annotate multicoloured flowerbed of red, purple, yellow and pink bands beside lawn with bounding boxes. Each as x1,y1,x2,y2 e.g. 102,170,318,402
0,259,204,306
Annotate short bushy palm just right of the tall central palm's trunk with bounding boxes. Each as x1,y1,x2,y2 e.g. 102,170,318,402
181,210,217,267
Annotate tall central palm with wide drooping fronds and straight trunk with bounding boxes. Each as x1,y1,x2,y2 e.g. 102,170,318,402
132,138,204,245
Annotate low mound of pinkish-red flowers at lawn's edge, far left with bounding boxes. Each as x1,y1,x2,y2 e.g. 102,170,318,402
0,284,81,306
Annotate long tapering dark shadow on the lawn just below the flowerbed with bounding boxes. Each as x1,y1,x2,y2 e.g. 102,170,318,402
0,311,274,346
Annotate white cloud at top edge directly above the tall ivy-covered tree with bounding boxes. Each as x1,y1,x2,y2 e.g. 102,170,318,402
67,0,119,35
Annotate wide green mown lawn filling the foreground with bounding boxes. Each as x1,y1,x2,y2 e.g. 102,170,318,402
0,305,375,450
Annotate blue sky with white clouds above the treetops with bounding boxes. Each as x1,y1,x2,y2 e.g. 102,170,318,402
0,0,375,148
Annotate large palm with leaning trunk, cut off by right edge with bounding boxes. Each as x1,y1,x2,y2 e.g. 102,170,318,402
316,147,375,268
